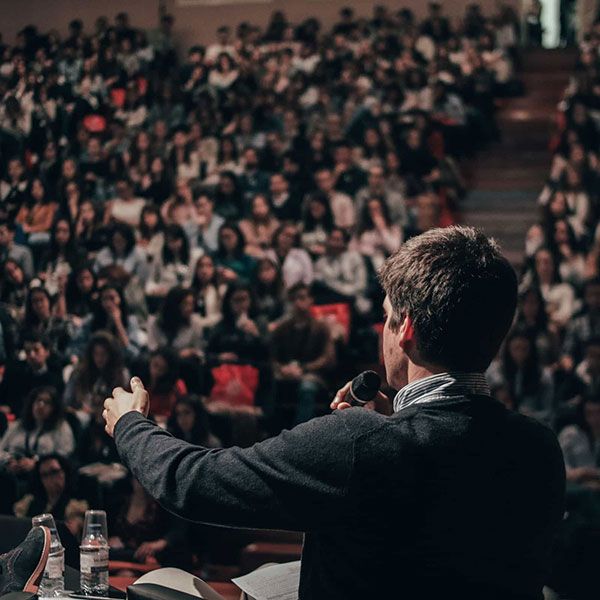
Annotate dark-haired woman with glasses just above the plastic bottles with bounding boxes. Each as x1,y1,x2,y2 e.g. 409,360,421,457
14,453,89,539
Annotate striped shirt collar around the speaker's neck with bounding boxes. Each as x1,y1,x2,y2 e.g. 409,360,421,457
394,373,490,412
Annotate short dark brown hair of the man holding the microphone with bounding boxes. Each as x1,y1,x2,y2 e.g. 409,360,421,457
380,227,517,372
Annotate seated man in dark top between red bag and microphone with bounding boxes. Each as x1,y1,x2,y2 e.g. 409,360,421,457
271,283,335,430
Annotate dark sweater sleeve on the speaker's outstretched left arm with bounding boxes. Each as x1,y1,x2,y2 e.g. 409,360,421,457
115,412,356,531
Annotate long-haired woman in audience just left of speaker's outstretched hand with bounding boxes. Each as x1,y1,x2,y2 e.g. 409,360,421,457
63,330,129,425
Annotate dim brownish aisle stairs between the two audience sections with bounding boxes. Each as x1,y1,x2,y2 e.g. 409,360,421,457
461,50,576,267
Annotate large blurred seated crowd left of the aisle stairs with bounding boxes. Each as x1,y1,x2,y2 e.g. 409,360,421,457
0,4,520,562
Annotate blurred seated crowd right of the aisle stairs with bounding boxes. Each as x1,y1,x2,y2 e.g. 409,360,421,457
488,17,600,598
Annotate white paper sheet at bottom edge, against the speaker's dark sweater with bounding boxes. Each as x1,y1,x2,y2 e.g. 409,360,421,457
232,560,300,600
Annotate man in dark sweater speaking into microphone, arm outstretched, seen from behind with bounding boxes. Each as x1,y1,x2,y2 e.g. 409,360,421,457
104,227,565,600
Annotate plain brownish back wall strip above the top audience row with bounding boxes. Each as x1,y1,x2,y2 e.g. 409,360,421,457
0,0,518,49
